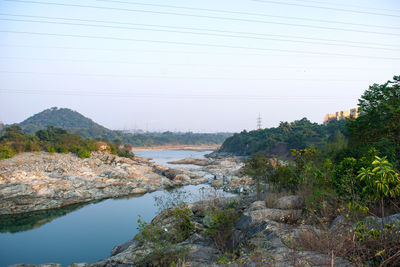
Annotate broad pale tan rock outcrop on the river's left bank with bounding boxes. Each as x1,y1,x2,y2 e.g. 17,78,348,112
0,152,207,215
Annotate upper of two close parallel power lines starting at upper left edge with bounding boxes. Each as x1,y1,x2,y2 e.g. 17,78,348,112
0,13,400,47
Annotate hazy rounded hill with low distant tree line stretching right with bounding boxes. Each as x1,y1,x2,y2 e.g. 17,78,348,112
14,107,230,147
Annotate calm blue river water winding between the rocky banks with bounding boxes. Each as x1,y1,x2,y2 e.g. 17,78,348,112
0,150,228,266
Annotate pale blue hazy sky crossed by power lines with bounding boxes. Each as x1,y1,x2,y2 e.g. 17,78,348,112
0,0,400,132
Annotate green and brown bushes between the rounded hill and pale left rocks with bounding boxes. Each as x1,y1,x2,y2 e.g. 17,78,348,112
0,126,133,160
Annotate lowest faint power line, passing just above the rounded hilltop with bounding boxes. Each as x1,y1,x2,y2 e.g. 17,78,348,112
0,89,359,102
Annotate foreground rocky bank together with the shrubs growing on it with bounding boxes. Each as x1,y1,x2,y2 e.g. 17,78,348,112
10,195,400,267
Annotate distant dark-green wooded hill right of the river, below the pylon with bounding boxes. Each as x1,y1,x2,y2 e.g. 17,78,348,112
219,118,346,158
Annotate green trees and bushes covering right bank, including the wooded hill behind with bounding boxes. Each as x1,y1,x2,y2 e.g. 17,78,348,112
238,76,400,266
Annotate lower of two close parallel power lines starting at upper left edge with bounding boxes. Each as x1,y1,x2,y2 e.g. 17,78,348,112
0,18,400,51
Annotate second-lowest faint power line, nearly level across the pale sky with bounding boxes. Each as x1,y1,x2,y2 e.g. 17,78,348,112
0,70,364,82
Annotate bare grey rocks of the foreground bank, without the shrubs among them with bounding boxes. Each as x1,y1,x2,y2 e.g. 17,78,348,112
72,196,362,267
